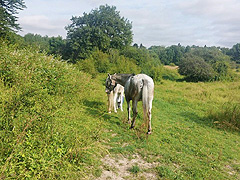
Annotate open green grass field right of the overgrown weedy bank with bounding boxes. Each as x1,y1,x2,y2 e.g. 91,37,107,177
94,75,240,179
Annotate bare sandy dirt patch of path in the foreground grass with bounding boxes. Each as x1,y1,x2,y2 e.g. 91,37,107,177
97,154,157,180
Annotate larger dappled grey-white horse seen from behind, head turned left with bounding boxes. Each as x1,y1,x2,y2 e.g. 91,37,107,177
106,74,154,134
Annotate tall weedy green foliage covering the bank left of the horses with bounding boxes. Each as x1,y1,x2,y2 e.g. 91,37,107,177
0,42,107,179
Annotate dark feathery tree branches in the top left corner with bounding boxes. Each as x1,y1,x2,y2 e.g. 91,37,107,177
0,0,26,37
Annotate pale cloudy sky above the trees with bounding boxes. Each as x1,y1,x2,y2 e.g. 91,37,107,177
18,0,240,48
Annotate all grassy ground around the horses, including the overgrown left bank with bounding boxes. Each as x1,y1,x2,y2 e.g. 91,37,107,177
0,43,240,179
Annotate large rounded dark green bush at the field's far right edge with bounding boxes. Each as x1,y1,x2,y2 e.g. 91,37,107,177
179,47,234,81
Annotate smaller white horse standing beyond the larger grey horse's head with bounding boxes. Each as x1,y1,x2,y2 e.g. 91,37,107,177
105,81,124,113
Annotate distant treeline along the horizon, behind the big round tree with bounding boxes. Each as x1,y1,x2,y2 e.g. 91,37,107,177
8,33,240,65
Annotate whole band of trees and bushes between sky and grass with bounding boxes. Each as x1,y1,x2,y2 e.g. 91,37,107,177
0,0,240,81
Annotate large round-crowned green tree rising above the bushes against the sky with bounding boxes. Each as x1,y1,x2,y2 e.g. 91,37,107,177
66,5,132,59
